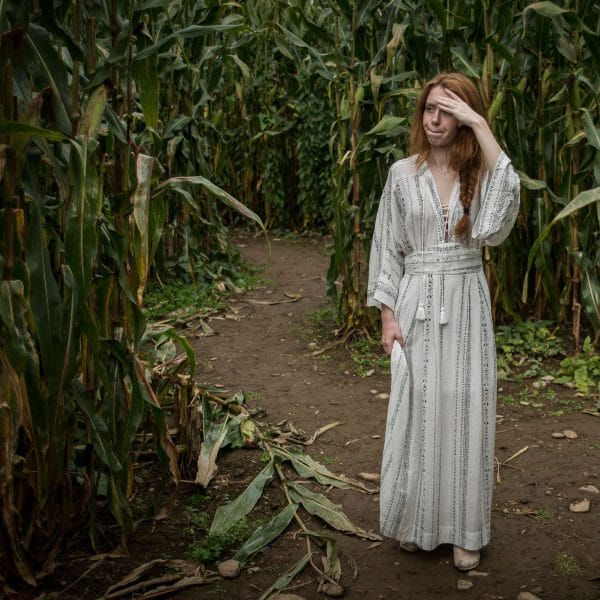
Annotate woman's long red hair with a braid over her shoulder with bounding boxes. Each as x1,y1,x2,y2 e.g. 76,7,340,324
410,73,487,240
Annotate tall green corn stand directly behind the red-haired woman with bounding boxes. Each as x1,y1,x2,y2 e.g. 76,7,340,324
284,0,600,347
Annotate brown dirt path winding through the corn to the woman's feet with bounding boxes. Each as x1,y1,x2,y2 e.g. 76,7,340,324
189,240,600,600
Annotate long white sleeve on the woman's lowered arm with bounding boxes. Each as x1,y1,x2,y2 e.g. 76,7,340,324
367,169,404,310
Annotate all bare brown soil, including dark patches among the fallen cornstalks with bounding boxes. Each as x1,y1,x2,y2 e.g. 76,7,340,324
38,233,600,600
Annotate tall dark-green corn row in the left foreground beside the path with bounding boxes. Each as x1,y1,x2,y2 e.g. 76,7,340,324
0,0,258,591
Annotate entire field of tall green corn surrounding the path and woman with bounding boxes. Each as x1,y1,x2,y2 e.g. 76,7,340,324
0,0,600,589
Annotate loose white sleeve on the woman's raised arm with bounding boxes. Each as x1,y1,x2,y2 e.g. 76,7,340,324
471,152,521,246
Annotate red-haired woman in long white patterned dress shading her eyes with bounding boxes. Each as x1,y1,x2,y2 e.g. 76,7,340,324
368,73,519,570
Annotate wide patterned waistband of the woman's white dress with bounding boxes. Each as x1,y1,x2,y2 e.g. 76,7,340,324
404,246,483,275
